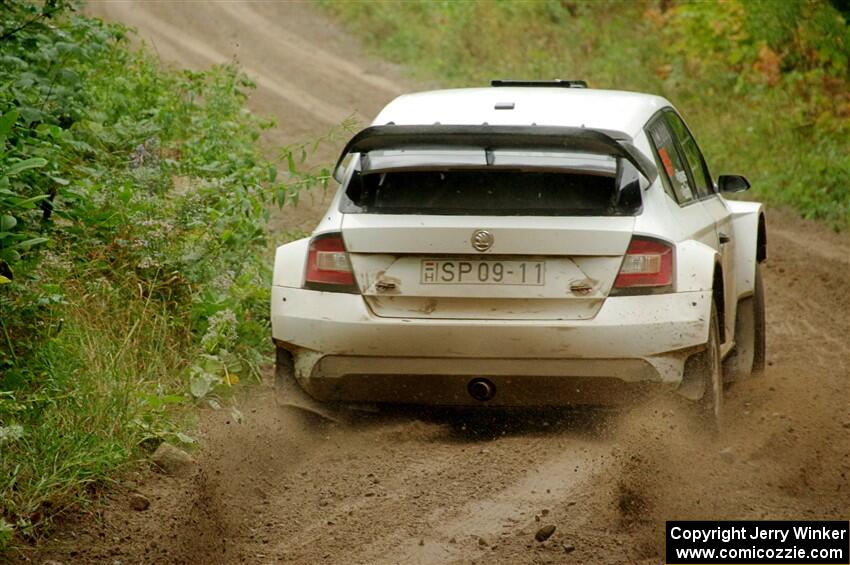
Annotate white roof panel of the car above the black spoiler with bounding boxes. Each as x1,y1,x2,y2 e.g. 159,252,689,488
372,87,672,137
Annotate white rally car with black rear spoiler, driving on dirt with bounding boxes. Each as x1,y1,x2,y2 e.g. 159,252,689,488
271,81,766,417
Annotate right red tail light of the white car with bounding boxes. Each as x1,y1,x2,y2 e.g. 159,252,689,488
612,236,673,295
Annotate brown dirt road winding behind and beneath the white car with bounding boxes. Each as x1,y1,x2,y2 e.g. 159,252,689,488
21,2,850,564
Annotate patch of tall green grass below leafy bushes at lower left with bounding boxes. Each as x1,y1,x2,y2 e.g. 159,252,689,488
0,279,192,535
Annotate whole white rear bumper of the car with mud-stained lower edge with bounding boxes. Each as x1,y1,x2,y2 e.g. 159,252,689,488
272,287,711,405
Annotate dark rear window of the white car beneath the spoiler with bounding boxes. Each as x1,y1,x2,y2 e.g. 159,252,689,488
340,149,641,216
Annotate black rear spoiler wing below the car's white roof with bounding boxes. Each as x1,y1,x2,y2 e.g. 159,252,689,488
334,124,658,184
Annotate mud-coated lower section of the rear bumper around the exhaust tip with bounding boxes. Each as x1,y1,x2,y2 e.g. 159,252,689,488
299,355,658,406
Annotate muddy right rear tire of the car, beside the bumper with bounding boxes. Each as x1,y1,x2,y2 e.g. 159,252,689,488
685,301,723,430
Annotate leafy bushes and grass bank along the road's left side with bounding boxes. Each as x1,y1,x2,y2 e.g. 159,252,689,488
0,0,326,552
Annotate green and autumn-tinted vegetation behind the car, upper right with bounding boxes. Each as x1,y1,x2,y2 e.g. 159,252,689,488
321,0,850,227
